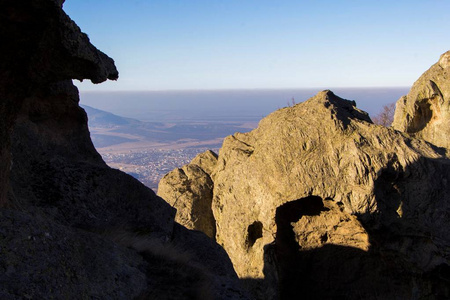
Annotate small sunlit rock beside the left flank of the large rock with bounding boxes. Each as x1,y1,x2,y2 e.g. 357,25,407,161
158,151,217,239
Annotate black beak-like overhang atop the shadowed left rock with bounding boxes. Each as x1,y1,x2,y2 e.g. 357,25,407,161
0,0,118,205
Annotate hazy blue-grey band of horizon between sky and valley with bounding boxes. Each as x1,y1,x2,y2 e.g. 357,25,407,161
80,87,409,122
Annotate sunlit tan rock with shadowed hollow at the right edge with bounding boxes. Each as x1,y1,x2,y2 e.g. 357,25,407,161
392,51,450,148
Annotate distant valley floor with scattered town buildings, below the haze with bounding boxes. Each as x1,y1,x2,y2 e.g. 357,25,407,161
83,106,257,191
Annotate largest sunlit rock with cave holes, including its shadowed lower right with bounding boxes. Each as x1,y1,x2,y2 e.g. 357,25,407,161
165,91,450,299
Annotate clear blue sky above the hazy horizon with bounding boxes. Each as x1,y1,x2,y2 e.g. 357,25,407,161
64,0,450,91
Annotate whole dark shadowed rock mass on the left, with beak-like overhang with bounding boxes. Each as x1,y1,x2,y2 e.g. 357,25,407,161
0,0,248,299
